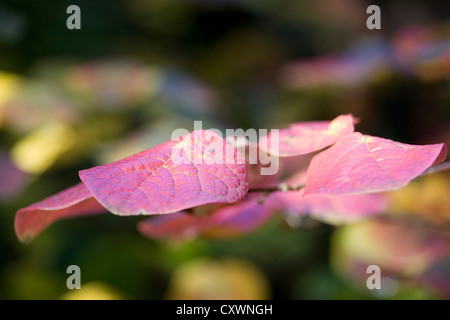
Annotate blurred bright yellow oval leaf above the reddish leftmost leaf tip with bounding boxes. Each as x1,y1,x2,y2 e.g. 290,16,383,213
11,121,77,174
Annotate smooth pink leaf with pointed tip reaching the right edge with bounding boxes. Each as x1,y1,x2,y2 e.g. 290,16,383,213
305,132,447,195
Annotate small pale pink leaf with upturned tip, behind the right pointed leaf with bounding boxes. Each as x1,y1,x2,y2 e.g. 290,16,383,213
259,114,355,157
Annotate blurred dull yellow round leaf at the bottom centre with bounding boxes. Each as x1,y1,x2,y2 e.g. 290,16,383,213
167,258,271,300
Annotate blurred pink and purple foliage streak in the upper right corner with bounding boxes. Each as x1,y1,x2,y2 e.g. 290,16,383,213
280,25,450,89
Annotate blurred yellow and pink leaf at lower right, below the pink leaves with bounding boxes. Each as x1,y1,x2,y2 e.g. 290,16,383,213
331,219,450,287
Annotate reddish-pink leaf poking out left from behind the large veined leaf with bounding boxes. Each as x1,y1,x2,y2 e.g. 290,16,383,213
14,183,106,242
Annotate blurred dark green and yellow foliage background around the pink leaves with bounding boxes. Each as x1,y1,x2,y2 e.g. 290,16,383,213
0,0,450,299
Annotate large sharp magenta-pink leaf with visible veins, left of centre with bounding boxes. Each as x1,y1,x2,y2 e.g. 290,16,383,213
80,130,248,215
